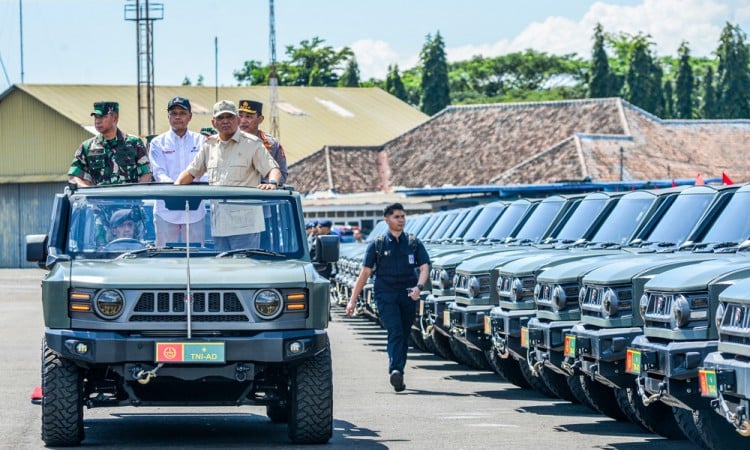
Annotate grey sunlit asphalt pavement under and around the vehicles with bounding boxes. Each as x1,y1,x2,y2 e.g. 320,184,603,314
0,269,696,450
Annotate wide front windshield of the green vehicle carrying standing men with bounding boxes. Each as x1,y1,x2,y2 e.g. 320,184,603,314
67,196,304,258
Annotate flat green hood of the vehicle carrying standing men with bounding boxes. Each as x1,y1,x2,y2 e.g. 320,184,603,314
70,258,315,288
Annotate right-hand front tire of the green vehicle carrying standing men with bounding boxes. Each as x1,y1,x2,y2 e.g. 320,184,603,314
289,342,333,444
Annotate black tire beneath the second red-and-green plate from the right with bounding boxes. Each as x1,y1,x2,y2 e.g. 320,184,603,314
615,381,687,440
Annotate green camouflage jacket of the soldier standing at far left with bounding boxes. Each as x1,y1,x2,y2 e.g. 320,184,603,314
68,129,151,185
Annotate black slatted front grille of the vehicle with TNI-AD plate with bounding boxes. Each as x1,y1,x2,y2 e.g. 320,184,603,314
129,291,249,322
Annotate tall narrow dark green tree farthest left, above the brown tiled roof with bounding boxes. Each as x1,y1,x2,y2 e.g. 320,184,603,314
419,31,450,115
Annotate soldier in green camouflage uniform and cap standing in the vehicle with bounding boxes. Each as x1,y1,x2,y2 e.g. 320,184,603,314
68,102,152,186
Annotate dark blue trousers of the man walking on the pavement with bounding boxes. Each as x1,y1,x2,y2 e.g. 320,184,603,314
375,288,417,373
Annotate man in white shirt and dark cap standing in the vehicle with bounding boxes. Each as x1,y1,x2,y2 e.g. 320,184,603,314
150,97,206,246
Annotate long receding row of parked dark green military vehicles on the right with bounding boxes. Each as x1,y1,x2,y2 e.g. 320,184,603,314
332,185,750,449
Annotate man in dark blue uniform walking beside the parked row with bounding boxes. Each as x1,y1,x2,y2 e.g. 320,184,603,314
346,203,430,392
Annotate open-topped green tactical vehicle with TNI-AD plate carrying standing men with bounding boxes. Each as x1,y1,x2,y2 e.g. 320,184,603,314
26,184,338,446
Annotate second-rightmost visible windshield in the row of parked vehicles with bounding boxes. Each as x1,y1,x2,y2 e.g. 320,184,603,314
646,193,715,245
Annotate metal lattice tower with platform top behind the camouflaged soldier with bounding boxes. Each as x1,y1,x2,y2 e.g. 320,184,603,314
125,0,164,136
